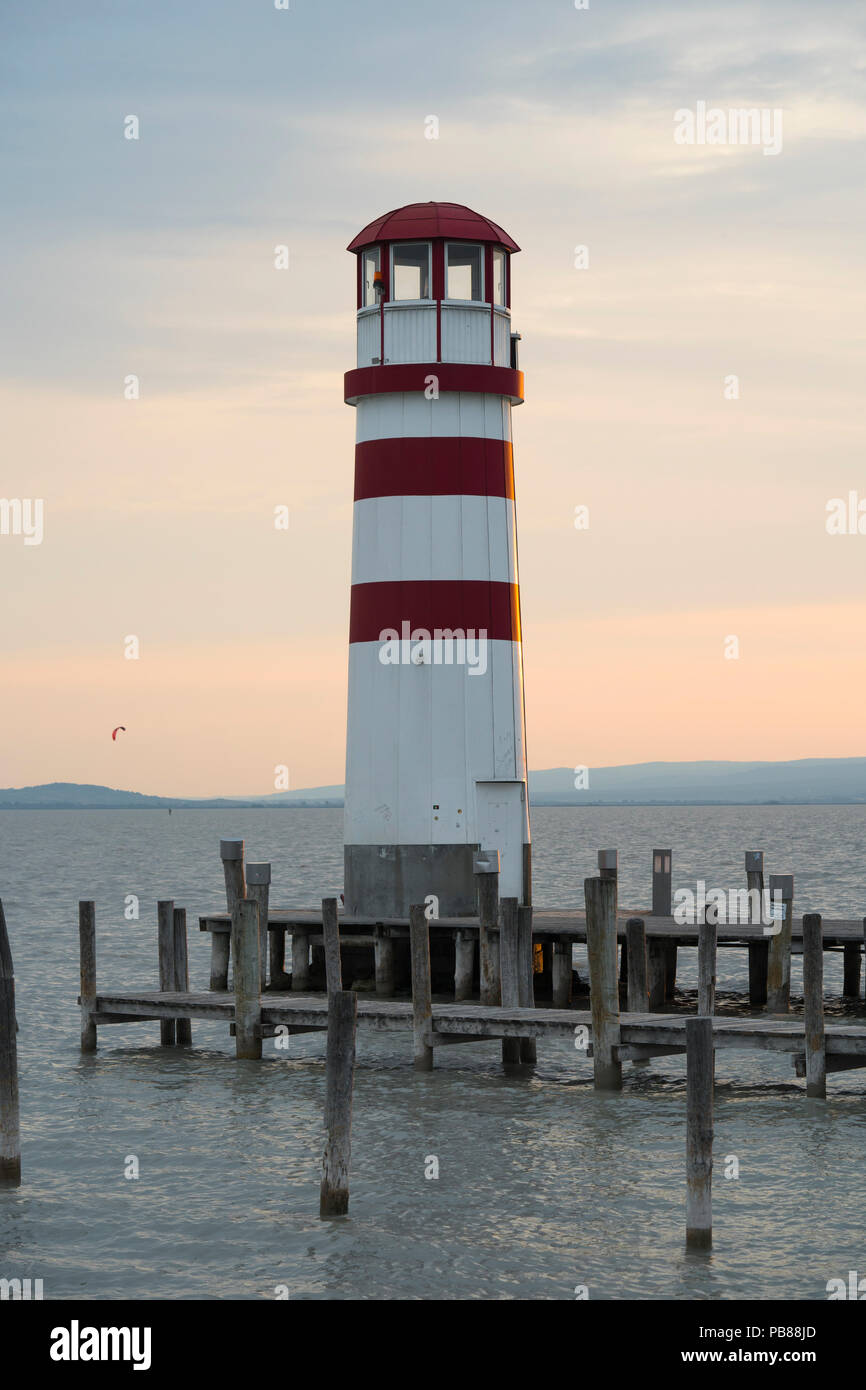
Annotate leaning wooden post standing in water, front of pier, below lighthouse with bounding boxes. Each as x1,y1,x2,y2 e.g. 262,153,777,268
318,990,357,1216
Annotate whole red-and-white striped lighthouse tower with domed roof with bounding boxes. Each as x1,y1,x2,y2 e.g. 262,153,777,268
345,203,530,917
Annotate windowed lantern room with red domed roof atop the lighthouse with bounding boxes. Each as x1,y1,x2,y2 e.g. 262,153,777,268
348,203,520,367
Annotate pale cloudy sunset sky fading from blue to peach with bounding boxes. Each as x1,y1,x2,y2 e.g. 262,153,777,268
0,0,866,796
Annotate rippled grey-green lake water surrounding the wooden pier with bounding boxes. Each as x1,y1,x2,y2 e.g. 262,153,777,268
0,806,866,1300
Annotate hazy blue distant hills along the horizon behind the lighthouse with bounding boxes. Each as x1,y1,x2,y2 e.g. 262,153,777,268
0,758,866,810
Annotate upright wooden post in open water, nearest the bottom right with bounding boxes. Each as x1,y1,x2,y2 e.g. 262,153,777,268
685,1017,713,1250
